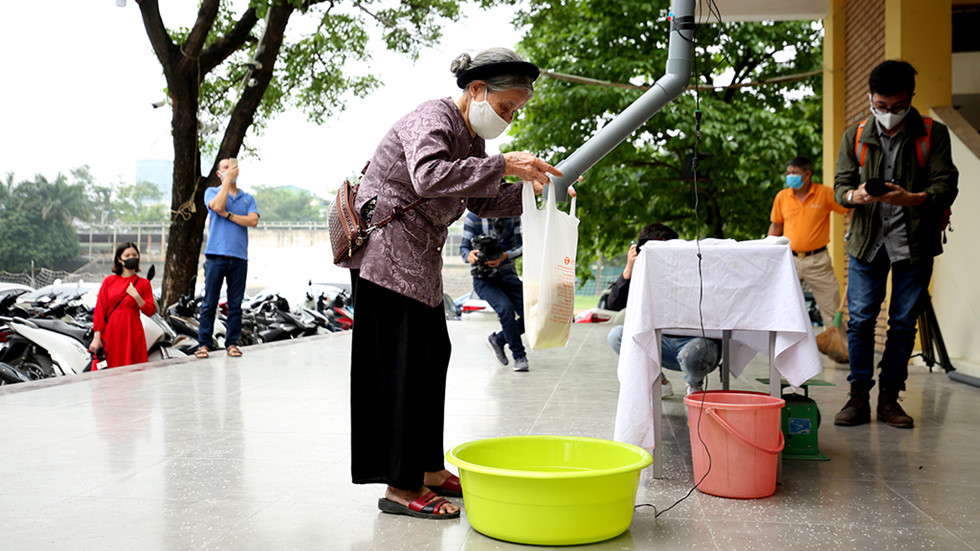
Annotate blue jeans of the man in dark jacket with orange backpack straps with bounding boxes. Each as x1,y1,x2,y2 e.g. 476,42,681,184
847,251,932,390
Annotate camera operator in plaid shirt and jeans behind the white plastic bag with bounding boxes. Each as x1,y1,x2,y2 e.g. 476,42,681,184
459,212,528,371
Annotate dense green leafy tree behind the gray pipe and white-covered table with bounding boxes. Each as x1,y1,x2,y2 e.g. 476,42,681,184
508,0,822,277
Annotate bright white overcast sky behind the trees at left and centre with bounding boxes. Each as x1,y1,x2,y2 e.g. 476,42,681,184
0,0,533,202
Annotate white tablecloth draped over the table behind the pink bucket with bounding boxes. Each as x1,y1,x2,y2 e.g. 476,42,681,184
614,237,823,449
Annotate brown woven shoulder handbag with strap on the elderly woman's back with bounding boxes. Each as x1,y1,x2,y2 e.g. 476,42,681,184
327,161,428,264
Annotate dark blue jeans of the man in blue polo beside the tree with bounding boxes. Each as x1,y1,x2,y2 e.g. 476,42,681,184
197,255,248,348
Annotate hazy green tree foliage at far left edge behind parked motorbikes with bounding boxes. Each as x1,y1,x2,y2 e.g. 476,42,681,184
0,174,91,272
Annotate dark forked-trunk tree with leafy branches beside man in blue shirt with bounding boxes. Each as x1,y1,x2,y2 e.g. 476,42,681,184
137,0,459,310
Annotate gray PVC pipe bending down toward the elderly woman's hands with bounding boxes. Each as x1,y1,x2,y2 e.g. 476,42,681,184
551,0,695,201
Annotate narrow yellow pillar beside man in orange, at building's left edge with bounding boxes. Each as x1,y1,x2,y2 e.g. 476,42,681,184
823,0,845,281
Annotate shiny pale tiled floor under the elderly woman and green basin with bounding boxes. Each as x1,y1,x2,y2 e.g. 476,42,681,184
0,320,980,551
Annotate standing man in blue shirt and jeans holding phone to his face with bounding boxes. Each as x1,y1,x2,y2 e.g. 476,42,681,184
194,159,259,358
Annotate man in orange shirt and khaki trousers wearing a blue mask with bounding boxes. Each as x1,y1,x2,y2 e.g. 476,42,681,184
769,157,848,334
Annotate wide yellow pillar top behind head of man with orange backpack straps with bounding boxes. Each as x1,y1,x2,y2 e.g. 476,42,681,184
885,0,953,109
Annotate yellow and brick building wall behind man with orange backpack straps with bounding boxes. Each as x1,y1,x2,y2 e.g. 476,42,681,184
824,0,980,364
